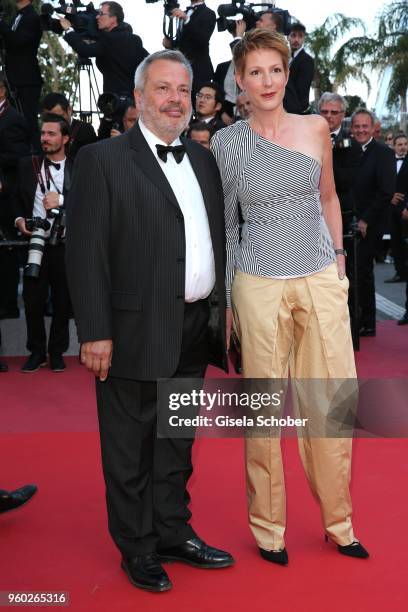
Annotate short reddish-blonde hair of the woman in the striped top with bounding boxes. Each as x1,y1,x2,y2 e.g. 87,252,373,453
234,28,289,75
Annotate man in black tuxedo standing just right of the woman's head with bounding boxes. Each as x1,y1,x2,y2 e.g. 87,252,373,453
283,23,314,115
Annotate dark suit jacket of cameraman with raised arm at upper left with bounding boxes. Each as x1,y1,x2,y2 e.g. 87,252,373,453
64,26,149,97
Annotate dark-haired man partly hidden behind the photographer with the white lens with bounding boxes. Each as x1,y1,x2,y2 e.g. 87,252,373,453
42,93,97,161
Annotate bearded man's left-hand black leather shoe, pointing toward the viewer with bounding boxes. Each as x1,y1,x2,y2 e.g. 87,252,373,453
121,553,173,593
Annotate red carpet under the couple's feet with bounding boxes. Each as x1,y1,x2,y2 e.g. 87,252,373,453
0,321,408,612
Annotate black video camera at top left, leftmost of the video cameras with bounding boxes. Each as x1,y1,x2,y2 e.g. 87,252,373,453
40,0,98,38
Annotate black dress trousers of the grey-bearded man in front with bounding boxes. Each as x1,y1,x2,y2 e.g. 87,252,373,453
96,300,209,557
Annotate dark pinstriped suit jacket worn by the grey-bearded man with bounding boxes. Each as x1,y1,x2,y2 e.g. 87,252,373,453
66,125,225,380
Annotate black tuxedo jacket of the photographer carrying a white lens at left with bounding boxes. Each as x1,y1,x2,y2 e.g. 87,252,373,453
14,155,72,219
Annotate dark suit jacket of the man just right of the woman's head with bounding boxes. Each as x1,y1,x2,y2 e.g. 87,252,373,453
283,49,314,115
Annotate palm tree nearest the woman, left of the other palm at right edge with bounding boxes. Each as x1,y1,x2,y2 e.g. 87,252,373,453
306,13,370,101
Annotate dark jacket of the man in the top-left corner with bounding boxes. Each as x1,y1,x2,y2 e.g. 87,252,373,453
0,5,42,87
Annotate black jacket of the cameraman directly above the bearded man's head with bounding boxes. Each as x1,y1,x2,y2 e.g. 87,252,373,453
176,4,216,89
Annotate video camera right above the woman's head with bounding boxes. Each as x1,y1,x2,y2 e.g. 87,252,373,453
217,0,292,35
